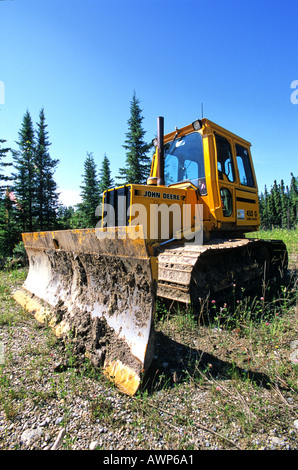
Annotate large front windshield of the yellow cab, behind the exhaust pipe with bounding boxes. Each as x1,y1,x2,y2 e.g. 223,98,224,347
164,132,206,194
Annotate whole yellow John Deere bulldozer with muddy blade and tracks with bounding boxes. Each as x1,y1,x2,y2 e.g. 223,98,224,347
14,117,287,395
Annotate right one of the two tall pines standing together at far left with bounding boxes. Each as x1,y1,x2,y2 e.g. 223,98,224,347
34,108,59,230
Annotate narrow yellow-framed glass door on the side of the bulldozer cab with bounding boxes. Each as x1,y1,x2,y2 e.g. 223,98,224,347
214,133,236,223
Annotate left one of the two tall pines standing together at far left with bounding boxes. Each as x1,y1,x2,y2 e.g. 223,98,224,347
12,110,36,232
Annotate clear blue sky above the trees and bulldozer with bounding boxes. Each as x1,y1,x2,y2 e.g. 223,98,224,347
0,0,298,204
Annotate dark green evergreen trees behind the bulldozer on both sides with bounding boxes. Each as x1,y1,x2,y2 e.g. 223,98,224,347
0,93,298,266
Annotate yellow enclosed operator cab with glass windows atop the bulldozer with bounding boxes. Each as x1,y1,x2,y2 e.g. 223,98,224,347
147,118,260,232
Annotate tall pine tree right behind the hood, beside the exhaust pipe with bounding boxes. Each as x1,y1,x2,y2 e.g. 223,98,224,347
119,92,151,184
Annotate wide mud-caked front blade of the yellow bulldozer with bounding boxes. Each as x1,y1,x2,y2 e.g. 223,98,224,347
14,227,157,395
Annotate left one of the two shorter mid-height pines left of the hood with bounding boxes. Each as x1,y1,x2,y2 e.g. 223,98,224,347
78,152,100,228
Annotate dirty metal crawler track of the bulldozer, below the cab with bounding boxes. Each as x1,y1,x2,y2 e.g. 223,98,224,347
157,239,287,308
